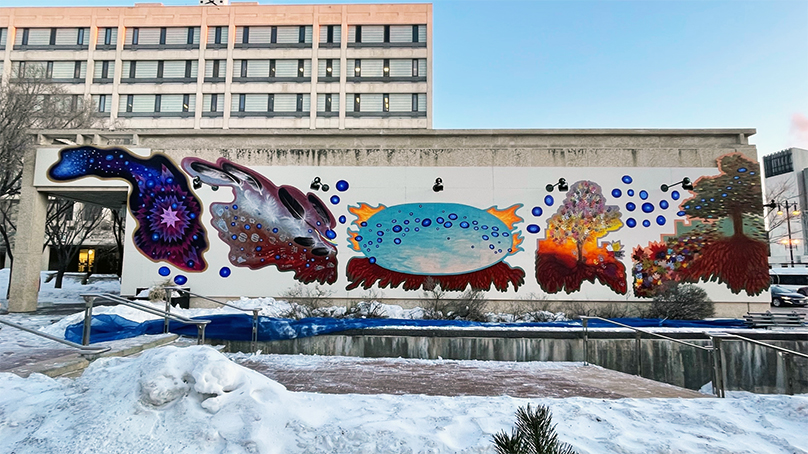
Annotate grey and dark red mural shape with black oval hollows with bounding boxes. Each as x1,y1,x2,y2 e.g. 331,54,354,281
182,158,337,284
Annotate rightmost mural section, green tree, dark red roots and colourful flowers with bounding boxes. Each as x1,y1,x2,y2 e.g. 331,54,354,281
632,153,769,297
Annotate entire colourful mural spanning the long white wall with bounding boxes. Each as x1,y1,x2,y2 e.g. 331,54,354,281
47,146,769,300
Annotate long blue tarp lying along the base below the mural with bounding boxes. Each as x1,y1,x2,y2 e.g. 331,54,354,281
65,314,745,343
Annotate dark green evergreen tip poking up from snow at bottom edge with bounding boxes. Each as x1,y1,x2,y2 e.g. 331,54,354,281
494,404,575,454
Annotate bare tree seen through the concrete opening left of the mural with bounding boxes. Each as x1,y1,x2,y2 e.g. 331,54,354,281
45,197,105,288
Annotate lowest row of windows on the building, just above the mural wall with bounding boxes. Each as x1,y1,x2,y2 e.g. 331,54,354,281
93,93,426,116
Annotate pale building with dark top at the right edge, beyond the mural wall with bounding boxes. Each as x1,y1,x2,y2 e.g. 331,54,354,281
763,148,808,266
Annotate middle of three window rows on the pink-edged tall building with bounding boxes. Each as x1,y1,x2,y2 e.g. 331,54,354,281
12,58,426,83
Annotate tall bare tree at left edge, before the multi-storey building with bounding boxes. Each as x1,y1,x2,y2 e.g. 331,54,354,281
0,64,98,272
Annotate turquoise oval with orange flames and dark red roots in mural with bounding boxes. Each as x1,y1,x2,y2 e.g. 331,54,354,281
346,203,525,291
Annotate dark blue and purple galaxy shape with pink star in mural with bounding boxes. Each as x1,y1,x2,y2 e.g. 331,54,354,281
48,146,208,271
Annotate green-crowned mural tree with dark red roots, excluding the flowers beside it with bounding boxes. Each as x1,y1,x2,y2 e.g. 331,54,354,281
681,153,769,295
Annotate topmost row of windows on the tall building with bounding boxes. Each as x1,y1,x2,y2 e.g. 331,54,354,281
0,25,426,50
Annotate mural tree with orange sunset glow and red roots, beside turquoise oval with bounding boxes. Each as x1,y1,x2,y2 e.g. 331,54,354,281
536,181,626,294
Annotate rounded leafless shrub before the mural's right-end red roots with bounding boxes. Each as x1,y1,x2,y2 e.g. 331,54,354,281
644,282,715,320
